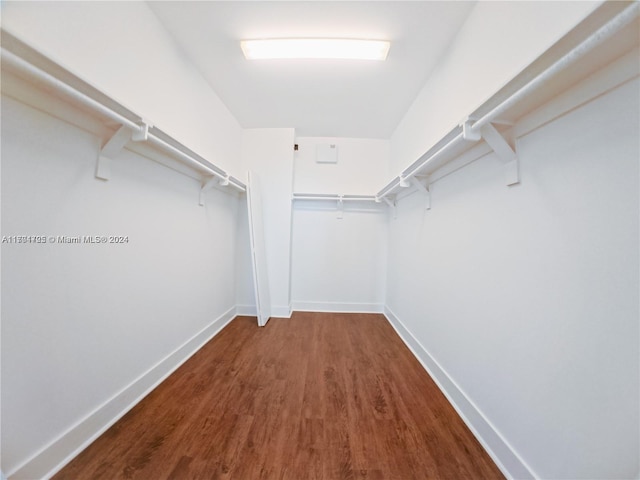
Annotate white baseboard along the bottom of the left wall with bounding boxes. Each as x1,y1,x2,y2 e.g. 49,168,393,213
7,307,236,479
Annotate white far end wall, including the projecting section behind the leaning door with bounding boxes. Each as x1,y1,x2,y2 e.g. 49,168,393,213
237,135,389,316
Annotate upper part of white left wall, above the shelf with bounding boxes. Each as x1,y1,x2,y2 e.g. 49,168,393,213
2,1,241,176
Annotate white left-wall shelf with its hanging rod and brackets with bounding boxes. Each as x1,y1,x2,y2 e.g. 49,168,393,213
1,30,246,205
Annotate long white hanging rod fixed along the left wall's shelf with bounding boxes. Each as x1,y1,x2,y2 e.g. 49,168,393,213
2,43,246,192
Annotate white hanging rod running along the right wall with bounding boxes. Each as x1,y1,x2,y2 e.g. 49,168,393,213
376,2,640,199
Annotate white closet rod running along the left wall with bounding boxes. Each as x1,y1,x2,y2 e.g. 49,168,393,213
2,47,246,192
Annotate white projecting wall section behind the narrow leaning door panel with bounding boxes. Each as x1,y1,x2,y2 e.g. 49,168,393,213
238,128,295,317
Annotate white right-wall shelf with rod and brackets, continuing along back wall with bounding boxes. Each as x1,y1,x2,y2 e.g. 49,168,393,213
294,2,640,210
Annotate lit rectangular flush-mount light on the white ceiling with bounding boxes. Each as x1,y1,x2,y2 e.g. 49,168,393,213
240,38,389,60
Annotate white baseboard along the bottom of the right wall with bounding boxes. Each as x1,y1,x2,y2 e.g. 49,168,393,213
384,306,538,480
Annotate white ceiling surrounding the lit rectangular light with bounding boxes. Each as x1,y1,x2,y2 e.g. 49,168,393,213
148,1,475,138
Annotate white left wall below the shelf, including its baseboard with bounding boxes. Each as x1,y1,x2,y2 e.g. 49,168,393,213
2,96,238,478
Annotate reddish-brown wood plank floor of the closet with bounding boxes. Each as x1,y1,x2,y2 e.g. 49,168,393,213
54,313,504,480
